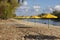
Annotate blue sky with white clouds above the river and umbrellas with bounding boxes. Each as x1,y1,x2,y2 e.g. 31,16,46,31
16,0,60,16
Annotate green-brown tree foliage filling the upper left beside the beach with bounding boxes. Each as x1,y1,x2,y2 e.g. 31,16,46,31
0,0,19,19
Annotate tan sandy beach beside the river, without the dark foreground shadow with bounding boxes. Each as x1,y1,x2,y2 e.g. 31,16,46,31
0,19,60,40
